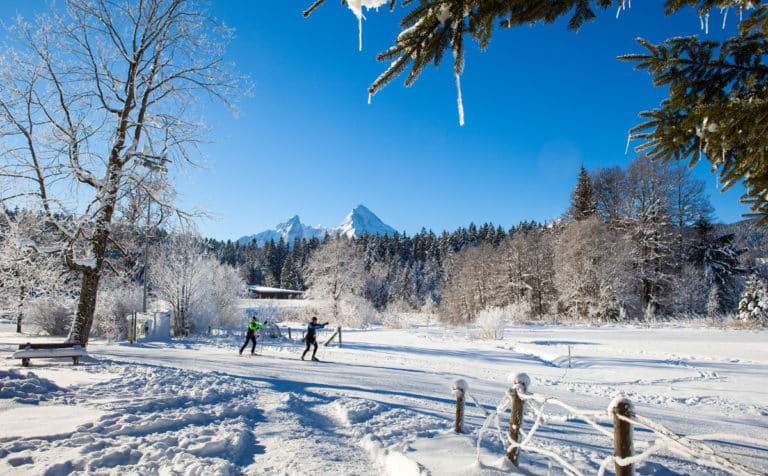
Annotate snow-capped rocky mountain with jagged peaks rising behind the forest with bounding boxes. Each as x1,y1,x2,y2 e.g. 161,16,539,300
237,205,395,246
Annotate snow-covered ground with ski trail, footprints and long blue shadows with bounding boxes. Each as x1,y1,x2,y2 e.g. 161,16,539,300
0,323,768,475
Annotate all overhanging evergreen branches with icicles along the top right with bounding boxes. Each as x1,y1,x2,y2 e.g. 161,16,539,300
304,0,768,224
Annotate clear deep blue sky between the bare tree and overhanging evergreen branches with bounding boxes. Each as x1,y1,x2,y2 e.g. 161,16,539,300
0,0,748,239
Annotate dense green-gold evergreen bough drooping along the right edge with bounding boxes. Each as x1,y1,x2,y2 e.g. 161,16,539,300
621,6,768,225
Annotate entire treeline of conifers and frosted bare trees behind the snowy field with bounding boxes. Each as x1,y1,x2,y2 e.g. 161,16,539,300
0,157,768,334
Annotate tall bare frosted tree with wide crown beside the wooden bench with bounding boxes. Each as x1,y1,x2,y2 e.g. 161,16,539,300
0,0,241,343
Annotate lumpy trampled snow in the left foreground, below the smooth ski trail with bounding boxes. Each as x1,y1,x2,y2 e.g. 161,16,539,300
0,346,445,475
